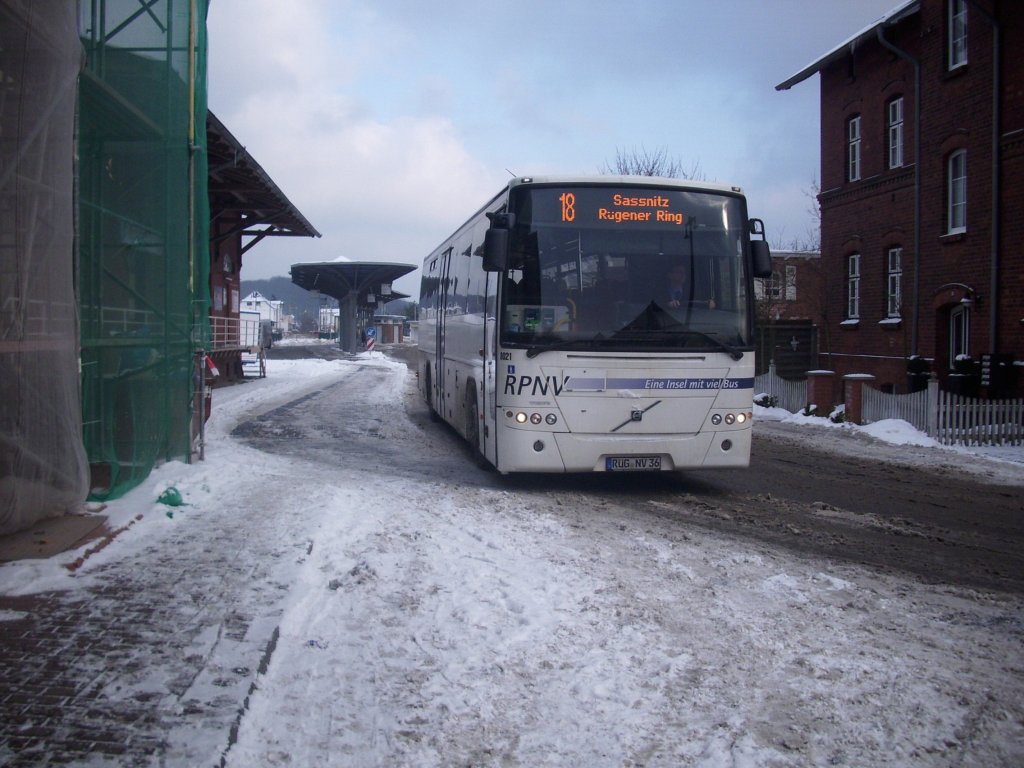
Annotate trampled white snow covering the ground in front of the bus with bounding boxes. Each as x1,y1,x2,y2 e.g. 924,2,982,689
0,353,1024,768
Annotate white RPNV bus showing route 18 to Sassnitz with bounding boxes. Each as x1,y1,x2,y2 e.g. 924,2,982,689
418,176,771,473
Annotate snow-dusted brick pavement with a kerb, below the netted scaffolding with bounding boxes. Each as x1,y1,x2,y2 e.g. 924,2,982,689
0,495,311,768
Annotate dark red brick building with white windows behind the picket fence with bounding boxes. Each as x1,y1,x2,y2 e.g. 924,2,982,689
776,0,1024,396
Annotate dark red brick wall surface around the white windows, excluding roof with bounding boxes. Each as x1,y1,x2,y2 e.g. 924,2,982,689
820,0,1024,391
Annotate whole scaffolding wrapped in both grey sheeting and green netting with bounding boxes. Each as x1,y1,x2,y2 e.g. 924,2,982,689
0,0,209,534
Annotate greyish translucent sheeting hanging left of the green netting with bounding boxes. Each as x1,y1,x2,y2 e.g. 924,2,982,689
0,0,88,534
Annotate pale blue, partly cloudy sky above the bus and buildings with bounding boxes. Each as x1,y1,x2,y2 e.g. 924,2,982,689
209,0,899,297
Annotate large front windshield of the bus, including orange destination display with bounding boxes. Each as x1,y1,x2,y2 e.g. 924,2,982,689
501,185,751,358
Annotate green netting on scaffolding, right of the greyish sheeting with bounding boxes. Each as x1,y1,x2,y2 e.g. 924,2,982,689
78,0,209,499
